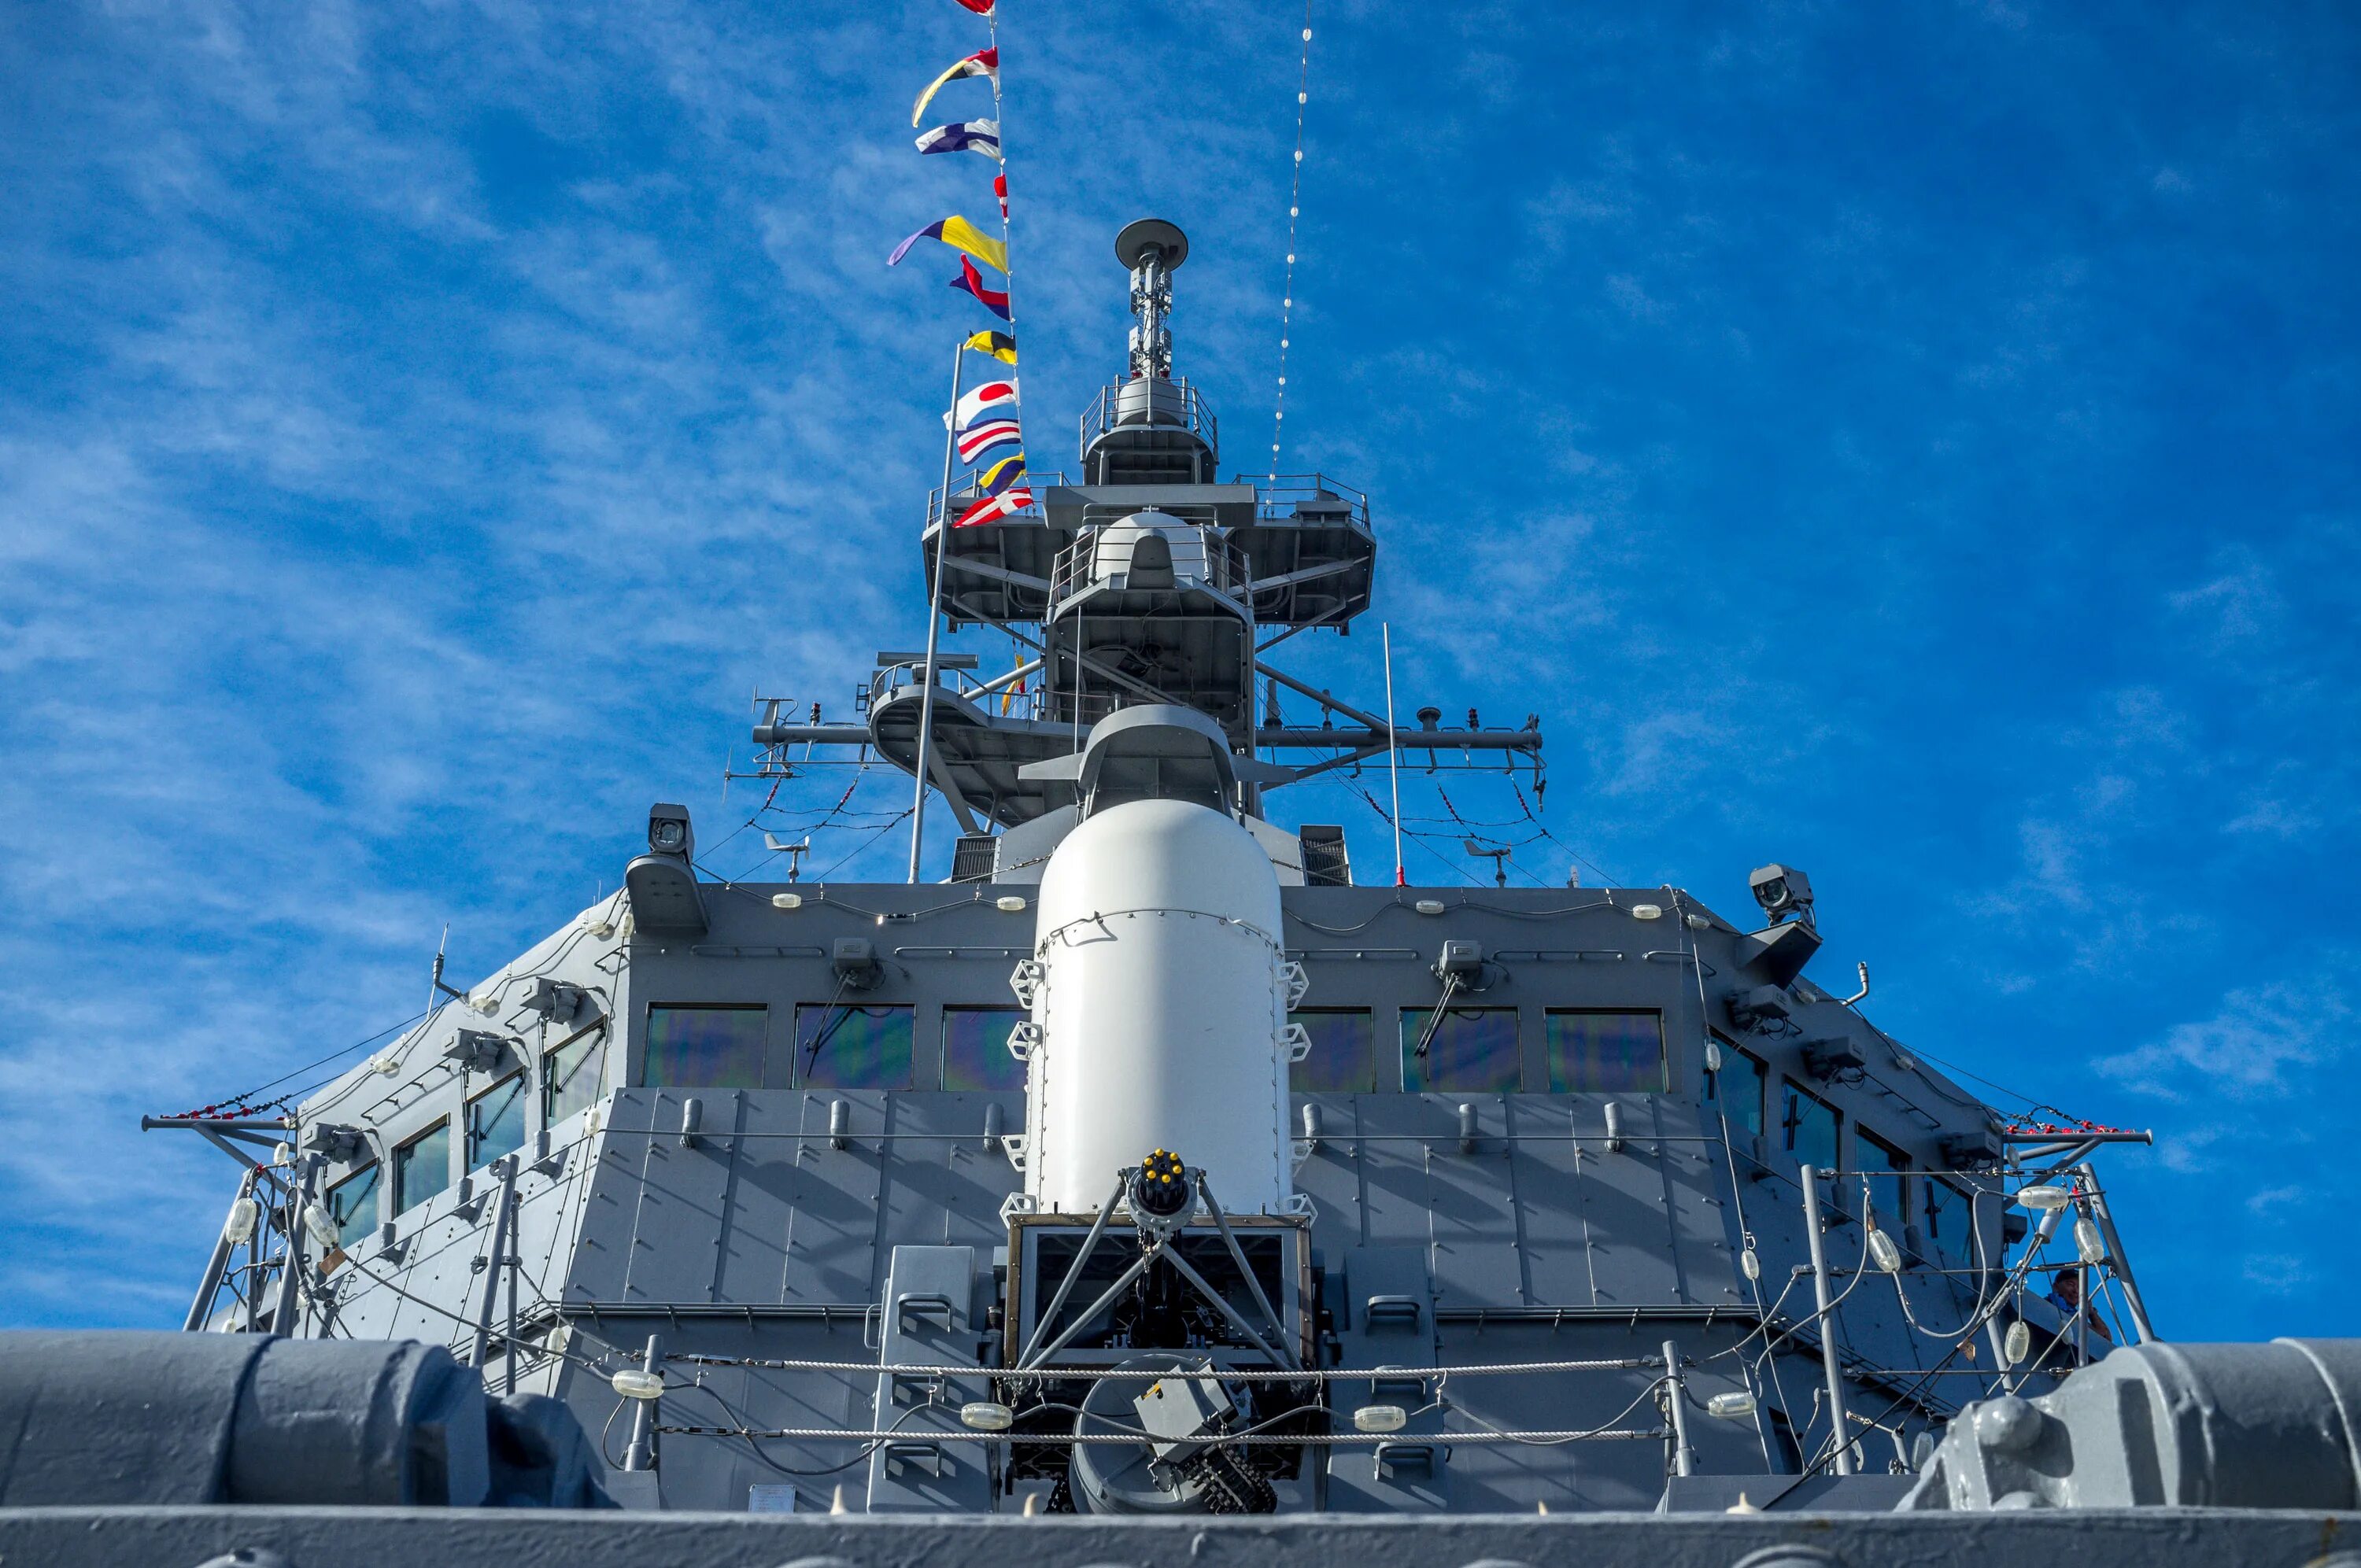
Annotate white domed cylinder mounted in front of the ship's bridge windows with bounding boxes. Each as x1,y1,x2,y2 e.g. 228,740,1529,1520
1025,799,1291,1214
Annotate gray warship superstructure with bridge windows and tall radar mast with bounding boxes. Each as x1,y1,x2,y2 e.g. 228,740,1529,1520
12,220,2361,1568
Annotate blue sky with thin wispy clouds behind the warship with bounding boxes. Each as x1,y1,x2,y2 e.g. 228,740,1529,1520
0,0,2361,1339
